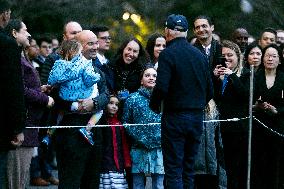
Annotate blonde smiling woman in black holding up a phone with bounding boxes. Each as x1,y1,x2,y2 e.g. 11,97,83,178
214,40,249,189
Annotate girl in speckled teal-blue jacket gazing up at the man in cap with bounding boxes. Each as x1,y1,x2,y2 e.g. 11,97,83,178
122,65,164,189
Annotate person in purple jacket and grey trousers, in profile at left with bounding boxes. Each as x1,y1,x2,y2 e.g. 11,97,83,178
5,20,54,189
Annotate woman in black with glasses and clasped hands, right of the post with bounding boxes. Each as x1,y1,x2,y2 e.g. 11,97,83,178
254,44,284,189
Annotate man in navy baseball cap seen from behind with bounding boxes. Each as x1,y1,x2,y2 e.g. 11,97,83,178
150,14,212,189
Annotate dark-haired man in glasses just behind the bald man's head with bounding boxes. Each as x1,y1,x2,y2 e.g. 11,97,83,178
90,25,111,69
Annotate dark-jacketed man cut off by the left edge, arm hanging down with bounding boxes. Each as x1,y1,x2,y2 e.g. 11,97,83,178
0,0,25,185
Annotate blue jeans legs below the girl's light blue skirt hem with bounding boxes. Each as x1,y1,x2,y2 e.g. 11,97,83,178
133,173,164,189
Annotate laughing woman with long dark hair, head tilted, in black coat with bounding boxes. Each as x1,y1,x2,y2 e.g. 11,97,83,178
102,37,149,99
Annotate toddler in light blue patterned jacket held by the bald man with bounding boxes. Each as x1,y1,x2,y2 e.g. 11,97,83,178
48,40,103,145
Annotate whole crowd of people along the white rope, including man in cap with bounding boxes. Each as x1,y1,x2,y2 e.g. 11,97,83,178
0,0,284,189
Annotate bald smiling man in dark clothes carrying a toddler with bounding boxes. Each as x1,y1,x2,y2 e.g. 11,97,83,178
56,30,109,189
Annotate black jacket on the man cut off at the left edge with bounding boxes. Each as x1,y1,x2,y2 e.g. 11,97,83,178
0,27,26,151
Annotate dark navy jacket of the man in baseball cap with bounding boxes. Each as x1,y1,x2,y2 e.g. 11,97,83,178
150,37,213,112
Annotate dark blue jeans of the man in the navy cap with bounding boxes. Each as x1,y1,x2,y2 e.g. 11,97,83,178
161,110,204,189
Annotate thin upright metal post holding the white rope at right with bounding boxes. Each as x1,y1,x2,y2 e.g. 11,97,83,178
247,65,254,189
